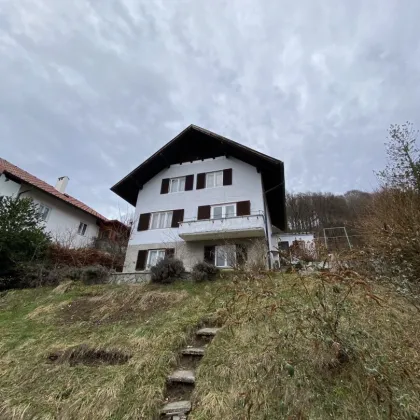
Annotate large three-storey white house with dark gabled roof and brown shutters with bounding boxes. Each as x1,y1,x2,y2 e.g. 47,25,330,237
111,125,286,273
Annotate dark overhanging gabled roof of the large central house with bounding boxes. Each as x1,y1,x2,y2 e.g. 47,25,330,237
111,125,286,230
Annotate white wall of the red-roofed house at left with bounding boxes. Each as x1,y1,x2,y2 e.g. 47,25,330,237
0,174,99,248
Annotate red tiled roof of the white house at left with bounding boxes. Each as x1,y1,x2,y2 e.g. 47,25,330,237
0,158,108,222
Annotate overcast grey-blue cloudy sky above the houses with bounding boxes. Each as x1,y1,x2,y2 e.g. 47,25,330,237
0,0,420,217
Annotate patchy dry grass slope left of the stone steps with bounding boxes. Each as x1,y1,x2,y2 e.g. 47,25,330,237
0,278,223,419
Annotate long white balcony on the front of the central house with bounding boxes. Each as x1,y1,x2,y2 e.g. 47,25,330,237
178,213,265,241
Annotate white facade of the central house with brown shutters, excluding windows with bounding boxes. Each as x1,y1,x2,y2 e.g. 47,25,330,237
124,157,278,272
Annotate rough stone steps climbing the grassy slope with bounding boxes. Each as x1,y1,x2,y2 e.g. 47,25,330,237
161,328,220,420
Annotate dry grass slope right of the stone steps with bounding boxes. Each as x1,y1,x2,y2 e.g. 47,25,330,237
191,270,420,420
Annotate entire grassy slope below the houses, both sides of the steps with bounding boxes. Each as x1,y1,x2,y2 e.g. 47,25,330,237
0,276,420,420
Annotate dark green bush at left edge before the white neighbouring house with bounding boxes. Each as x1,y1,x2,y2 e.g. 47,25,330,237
0,197,50,289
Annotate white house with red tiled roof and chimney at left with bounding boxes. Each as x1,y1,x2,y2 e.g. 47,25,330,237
0,158,123,248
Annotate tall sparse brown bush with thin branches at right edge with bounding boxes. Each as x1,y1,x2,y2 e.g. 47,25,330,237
360,123,420,287
